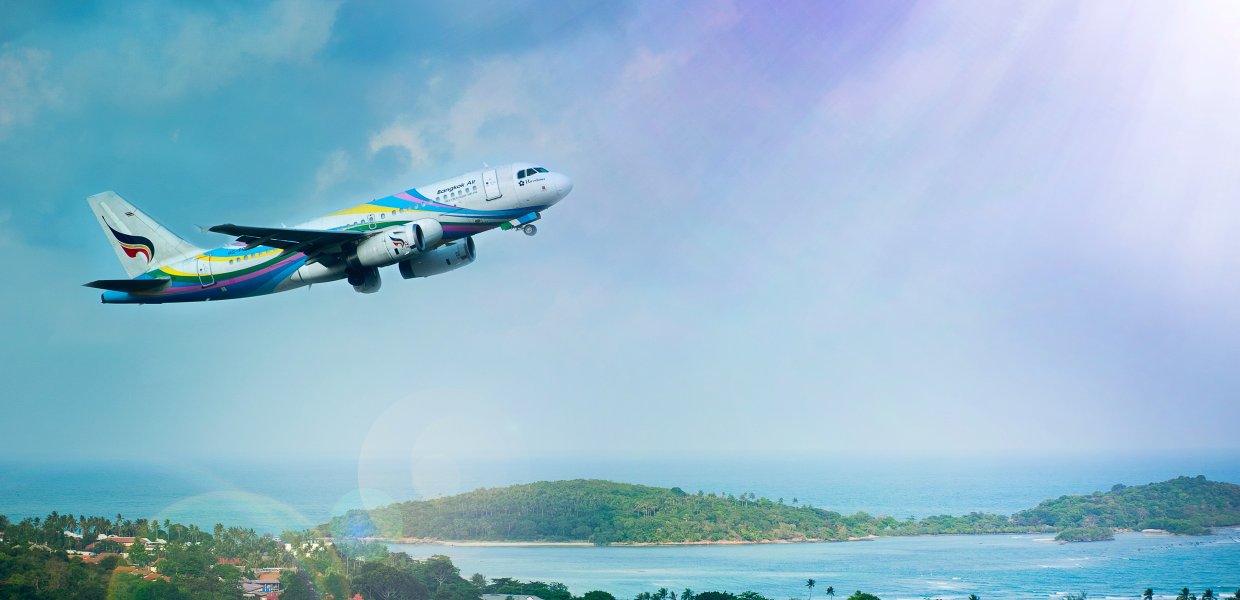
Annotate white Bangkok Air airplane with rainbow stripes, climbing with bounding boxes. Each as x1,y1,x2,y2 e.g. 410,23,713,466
84,162,573,304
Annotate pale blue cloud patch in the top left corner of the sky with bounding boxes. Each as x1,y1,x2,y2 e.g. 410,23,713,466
0,0,339,123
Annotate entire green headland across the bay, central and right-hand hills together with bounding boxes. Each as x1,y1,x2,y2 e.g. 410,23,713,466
320,477,1240,544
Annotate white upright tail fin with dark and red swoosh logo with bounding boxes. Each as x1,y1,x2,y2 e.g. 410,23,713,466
86,192,202,278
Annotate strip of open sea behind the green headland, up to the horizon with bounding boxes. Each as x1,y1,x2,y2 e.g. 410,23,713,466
0,455,1240,531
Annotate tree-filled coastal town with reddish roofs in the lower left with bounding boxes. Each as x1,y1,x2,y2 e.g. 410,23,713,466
0,512,575,600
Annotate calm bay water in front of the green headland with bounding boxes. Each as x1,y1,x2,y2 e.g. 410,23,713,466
391,528,1240,600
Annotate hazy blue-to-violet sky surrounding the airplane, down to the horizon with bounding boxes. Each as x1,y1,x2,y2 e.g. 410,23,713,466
0,1,1240,461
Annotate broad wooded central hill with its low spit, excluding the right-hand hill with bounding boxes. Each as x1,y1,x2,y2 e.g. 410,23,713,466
321,480,1038,544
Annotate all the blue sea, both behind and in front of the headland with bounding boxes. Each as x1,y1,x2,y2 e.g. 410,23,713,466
0,455,1240,599
